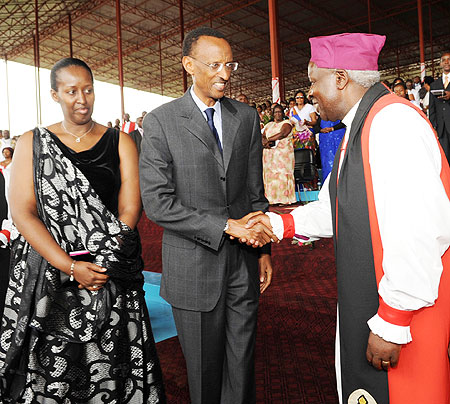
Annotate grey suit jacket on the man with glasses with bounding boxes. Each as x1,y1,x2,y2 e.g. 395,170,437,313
140,90,268,311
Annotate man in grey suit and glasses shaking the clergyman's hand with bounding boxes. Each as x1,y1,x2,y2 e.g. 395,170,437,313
140,27,276,404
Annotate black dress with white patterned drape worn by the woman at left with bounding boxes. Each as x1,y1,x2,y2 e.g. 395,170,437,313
0,128,165,404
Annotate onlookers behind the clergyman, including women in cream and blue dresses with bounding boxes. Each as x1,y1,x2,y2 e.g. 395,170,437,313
236,71,442,205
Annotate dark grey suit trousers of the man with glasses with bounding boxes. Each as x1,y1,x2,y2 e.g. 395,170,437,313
172,246,259,404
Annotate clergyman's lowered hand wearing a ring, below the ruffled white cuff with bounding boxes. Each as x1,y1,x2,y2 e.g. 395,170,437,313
366,331,402,370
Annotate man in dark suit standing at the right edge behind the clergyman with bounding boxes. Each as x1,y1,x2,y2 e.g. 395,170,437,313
429,52,450,162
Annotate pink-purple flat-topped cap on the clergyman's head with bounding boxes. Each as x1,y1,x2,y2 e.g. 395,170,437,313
309,33,386,70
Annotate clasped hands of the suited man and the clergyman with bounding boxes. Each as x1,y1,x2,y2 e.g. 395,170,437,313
225,211,279,248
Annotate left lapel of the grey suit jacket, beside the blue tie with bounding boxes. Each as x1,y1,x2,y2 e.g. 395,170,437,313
180,90,224,167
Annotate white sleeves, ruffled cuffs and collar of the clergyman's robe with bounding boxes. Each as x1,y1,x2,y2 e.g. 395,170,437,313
268,98,450,344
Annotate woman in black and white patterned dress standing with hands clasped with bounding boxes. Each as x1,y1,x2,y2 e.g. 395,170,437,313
0,58,165,404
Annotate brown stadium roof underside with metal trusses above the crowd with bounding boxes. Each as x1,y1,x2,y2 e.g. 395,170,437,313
0,0,450,100
